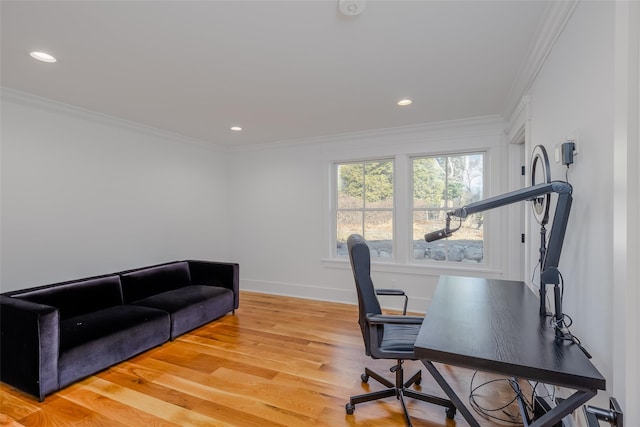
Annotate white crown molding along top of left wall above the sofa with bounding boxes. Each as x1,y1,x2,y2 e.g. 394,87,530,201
0,87,227,152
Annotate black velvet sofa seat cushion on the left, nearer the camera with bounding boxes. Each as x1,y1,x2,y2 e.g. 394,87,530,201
58,305,170,388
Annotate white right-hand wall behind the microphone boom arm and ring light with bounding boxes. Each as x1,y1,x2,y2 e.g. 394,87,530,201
528,2,637,412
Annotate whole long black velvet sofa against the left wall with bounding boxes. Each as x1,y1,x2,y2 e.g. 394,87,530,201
0,260,239,401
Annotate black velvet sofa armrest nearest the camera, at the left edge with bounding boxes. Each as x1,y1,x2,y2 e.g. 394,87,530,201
0,295,60,401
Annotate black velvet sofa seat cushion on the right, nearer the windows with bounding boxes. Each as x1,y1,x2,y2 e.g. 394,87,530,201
134,285,234,340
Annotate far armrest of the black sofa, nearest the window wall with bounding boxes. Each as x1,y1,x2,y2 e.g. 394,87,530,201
187,260,240,309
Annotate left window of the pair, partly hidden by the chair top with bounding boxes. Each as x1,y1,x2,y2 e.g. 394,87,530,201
334,159,394,258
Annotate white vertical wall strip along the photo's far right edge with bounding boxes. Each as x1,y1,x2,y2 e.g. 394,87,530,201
612,2,640,425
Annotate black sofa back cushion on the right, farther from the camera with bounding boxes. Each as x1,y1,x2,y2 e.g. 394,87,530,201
120,261,191,303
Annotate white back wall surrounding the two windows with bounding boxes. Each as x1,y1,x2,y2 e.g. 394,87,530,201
230,118,508,311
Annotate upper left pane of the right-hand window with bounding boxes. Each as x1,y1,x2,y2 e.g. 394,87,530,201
413,157,446,208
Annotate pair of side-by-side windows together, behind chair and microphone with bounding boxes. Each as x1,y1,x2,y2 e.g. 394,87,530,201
331,151,488,265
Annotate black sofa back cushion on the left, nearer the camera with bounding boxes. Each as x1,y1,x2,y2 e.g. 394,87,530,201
13,275,122,320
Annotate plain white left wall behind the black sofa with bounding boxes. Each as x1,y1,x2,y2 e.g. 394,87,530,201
0,90,229,291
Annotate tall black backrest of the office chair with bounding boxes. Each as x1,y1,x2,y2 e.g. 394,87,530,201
347,234,382,356
